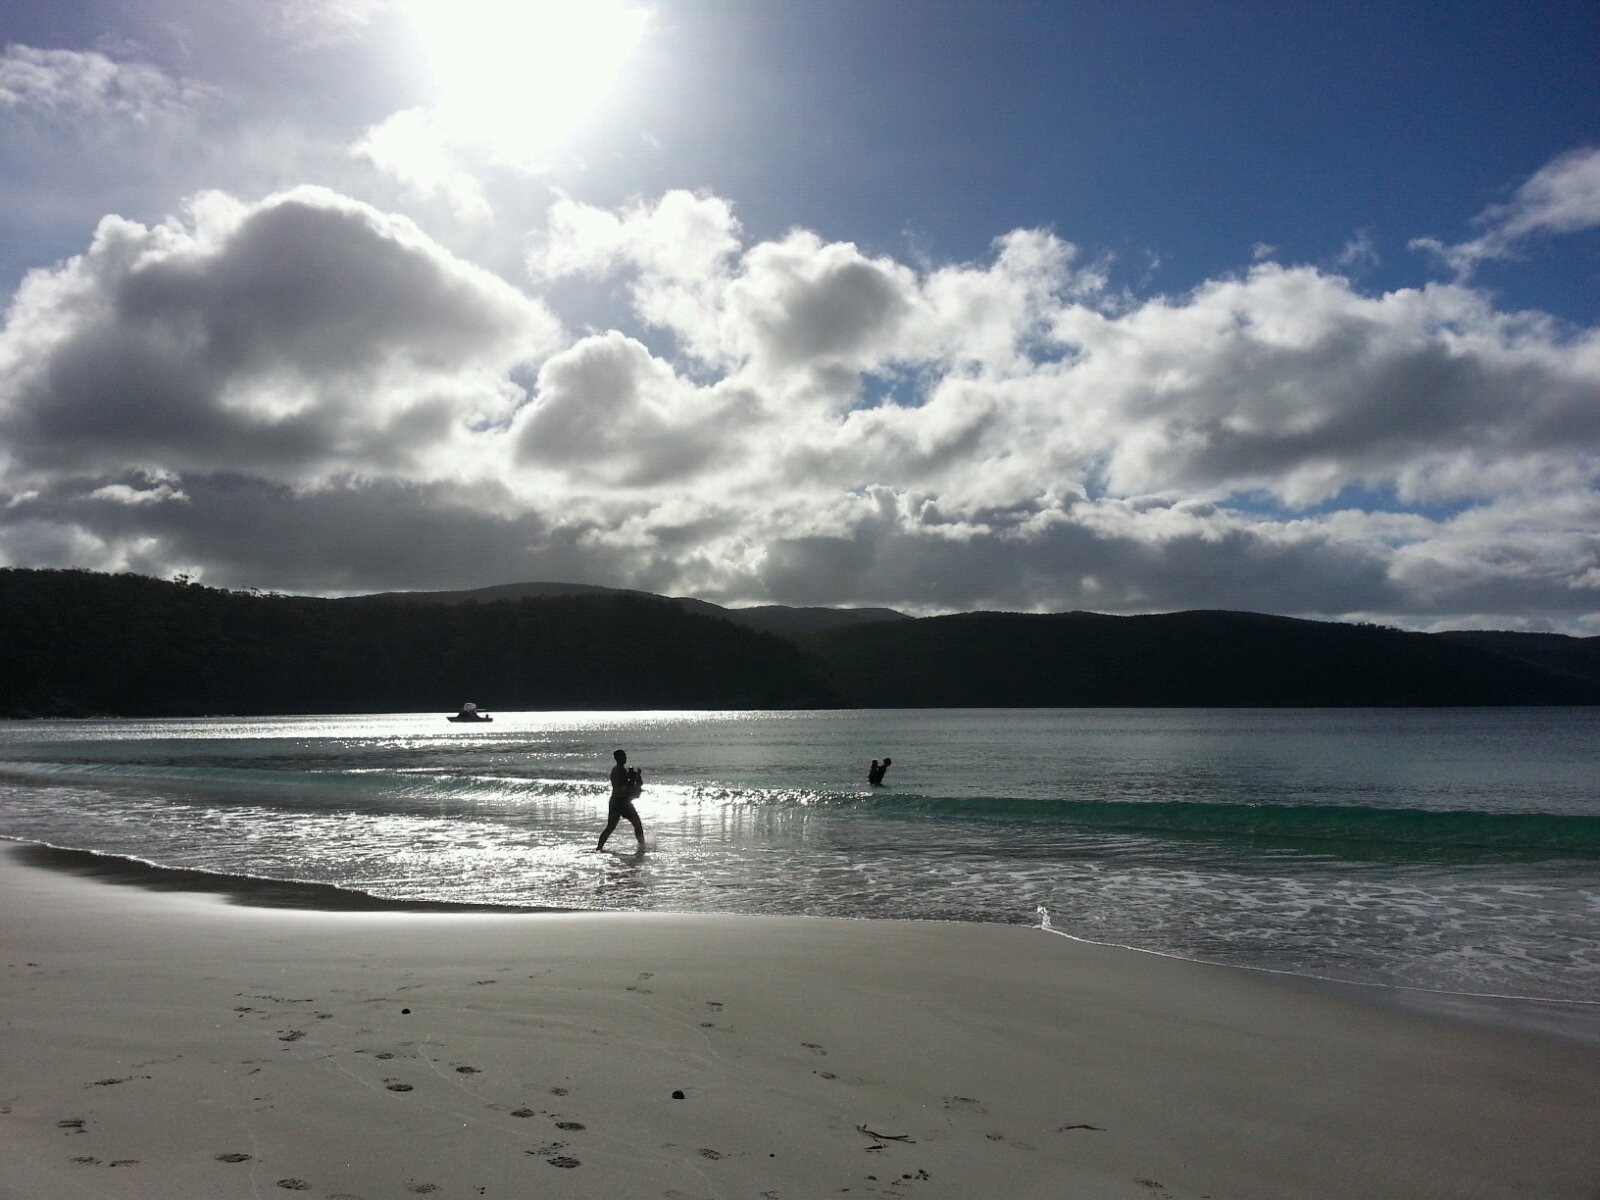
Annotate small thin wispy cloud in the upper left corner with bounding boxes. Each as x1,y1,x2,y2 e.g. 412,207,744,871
0,45,206,122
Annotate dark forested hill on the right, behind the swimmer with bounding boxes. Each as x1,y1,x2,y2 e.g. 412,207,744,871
818,611,1600,707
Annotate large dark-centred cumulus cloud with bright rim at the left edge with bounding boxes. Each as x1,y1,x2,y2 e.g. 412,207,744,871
0,187,557,482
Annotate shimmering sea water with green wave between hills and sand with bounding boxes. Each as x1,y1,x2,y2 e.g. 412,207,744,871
0,709,1600,1002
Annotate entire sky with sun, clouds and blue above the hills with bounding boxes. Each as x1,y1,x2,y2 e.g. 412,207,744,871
0,0,1600,635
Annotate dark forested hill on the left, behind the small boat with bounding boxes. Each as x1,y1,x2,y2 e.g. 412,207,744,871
0,570,838,715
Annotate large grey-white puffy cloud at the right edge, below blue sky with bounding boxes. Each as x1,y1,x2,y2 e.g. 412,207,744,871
1056,266,1600,506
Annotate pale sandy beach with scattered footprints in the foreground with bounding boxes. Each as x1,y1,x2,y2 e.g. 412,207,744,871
0,850,1600,1200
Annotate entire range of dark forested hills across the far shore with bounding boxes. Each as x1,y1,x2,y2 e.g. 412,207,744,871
0,570,1600,717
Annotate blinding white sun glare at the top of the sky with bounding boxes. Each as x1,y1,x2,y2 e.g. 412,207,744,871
408,0,650,162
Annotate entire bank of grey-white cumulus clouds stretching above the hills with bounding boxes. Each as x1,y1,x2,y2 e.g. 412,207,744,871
0,178,1600,624
